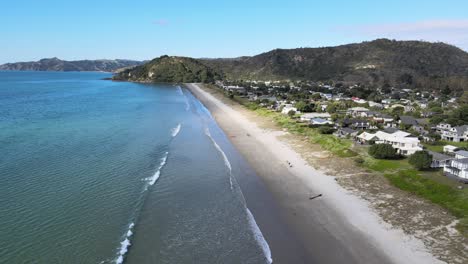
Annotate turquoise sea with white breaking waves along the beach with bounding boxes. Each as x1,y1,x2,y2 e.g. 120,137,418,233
0,72,270,263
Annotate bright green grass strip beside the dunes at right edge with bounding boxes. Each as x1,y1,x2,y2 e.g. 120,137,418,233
384,169,468,235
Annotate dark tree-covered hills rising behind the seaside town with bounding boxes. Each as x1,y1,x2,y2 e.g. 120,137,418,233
115,39,468,90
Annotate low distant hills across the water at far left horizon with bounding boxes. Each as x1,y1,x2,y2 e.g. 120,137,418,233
0,58,143,72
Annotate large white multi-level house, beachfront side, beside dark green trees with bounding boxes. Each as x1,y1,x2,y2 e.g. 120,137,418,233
358,131,423,156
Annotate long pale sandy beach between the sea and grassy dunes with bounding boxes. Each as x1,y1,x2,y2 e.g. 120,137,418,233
187,84,443,263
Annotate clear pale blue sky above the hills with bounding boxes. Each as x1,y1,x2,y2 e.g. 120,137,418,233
0,0,468,64
